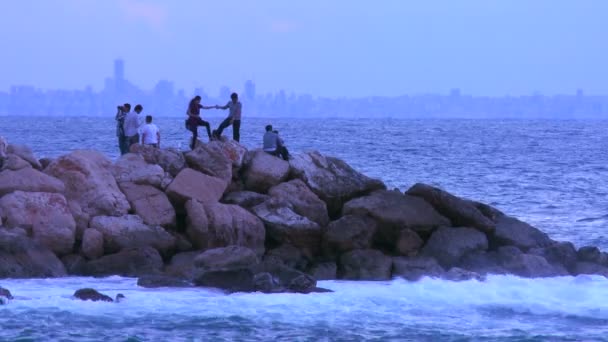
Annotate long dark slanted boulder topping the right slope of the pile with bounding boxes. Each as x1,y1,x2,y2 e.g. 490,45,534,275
406,183,495,233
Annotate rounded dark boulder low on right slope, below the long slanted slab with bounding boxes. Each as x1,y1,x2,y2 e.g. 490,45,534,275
422,227,488,268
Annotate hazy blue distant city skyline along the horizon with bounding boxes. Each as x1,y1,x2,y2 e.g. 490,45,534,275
0,59,608,119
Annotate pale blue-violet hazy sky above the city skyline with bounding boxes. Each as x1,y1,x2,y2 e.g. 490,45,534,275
0,0,608,97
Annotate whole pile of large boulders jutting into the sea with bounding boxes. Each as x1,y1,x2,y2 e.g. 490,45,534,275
0,140,608,293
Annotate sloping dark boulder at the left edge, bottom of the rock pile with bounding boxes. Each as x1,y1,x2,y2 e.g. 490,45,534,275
0,228,66,278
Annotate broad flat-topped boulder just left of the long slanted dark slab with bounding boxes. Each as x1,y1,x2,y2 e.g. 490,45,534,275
342,190,450,244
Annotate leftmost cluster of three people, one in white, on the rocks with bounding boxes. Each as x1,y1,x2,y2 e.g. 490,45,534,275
115,103,160,155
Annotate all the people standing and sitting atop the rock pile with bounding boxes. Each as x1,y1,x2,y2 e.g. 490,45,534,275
116,93,289,160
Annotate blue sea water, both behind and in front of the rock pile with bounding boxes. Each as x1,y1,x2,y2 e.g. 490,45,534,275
0,116,608,341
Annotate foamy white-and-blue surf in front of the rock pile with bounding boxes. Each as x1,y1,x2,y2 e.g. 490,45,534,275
0,276,608,340
